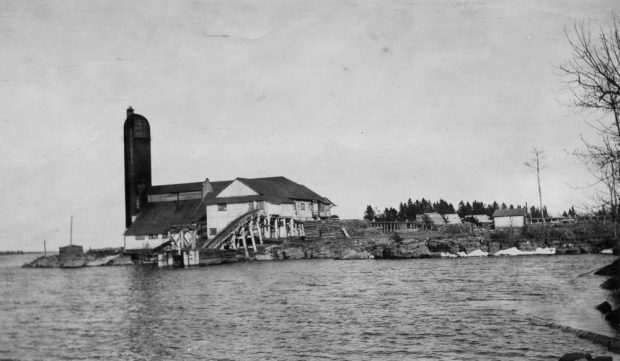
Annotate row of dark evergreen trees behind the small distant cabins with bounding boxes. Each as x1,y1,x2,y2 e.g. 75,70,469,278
364,198,577,222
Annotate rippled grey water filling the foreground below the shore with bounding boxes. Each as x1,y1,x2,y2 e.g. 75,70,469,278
0,255,618,360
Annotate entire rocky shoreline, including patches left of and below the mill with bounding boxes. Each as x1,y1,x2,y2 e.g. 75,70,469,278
24,220,620,266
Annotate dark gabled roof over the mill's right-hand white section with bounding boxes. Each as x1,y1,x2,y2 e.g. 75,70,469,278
205,177,333,204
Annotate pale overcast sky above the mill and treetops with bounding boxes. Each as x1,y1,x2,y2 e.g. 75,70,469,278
0,0,620,250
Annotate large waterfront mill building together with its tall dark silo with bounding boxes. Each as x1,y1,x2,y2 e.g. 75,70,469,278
124,108,334,249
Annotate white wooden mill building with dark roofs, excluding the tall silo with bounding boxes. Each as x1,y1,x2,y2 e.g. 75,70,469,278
124,177,334,249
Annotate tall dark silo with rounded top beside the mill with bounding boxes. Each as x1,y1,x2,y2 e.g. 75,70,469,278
124,107,151,228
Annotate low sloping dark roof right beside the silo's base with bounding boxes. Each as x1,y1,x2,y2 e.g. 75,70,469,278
125,198,206,236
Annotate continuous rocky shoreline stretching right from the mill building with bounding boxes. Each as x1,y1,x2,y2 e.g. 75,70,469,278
270,221,615,259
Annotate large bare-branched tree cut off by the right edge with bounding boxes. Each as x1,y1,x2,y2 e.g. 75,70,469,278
559,13,620,225
